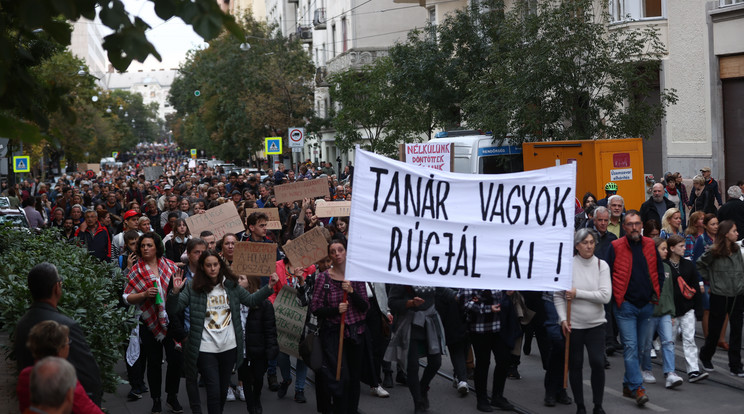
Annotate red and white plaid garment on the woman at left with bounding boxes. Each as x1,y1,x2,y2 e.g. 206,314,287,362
124,257,176,341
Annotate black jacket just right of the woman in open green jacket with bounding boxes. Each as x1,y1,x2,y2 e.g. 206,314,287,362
243,300,279,361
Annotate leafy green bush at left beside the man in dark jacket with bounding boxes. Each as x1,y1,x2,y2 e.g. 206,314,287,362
0,227,131,392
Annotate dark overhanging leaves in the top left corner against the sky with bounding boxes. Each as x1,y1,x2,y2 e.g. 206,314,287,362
0,0,243,142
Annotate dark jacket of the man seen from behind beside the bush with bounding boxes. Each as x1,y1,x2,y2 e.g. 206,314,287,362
13,302,103,408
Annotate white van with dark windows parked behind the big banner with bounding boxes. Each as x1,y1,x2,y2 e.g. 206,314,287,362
430,130,524,174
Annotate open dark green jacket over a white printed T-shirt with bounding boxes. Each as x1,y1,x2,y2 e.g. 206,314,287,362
165,280,274,379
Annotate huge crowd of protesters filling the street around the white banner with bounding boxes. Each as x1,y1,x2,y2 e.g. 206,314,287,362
8,147,744,414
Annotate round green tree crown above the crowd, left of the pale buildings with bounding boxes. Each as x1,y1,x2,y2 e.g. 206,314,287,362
168,15,314,160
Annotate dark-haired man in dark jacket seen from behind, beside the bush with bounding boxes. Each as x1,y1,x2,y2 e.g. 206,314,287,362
13,262,103,406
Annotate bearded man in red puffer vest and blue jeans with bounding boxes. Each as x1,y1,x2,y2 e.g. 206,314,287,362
607,210,664,407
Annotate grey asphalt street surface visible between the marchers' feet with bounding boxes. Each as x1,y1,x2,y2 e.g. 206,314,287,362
0,324,744,414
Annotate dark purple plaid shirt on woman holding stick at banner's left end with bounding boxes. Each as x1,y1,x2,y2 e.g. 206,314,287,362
310,270,369,337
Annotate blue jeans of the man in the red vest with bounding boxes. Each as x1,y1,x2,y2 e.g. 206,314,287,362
613,301,654,391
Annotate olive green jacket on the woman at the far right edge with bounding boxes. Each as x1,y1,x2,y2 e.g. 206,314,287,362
696,248,744,296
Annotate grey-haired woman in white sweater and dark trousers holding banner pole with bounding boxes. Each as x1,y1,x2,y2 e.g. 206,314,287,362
553,228,612,414
